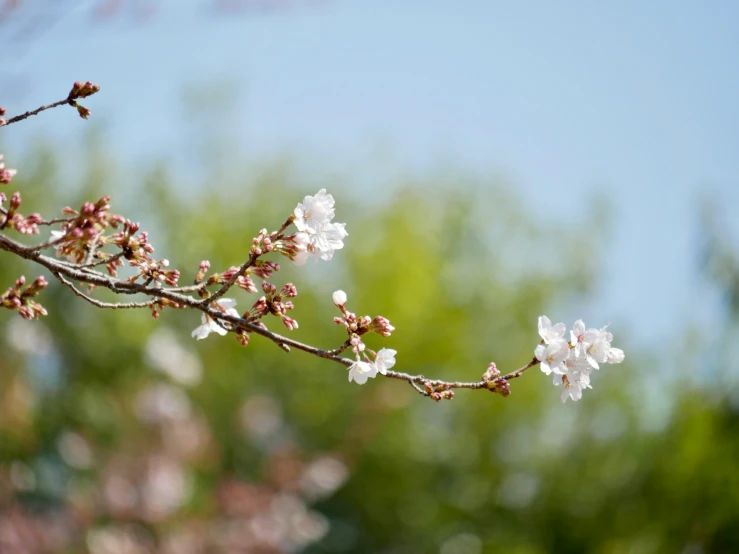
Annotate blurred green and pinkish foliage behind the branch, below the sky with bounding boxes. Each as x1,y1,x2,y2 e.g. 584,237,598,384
0,141,739,554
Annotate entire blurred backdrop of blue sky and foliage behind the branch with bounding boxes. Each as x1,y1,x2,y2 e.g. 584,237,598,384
0,0,739,554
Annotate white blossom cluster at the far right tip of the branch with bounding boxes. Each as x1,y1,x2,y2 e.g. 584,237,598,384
534,315,624,402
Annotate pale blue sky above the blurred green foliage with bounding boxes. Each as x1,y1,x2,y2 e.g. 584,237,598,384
0,0,739,345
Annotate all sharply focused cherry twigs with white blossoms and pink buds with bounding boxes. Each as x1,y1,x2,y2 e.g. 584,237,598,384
0,81,624,402
